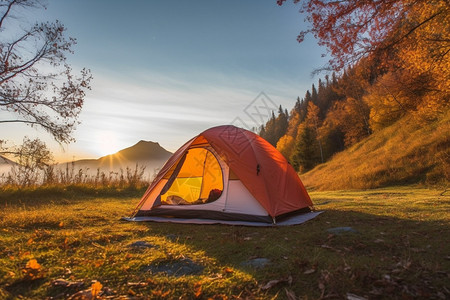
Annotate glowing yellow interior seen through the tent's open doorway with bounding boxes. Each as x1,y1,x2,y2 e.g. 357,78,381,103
161,148,223,205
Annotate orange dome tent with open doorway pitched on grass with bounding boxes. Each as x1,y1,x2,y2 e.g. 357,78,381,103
125,125,318,226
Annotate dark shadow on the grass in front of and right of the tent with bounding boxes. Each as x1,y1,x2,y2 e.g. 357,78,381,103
136,210,450,299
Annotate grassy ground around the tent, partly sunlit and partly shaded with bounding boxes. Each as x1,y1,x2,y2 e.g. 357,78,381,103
0,187,450,299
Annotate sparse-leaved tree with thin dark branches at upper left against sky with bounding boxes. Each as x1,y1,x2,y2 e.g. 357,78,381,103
0,0,92,149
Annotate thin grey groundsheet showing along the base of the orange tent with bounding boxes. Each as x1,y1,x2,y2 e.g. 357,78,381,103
122,211,323,227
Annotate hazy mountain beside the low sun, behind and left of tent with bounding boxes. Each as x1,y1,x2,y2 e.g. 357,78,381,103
59,141,172,176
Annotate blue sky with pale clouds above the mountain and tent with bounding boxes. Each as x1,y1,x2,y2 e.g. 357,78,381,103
0,0,327,161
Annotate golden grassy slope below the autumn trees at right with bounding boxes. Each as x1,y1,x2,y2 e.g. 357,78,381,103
301,113,450,190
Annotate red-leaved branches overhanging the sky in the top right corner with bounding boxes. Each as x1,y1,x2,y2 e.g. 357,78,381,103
277,0,449,70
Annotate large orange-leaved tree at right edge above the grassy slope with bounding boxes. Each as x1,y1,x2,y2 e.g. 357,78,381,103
366,1,450,123
